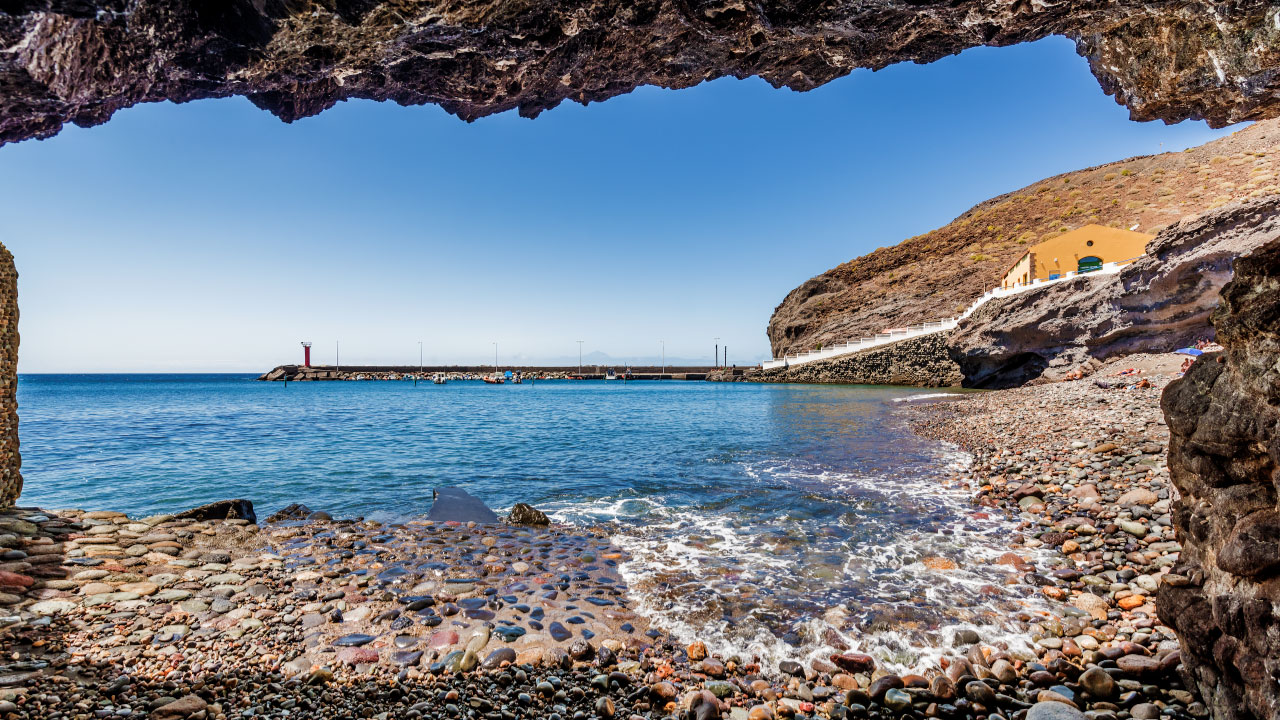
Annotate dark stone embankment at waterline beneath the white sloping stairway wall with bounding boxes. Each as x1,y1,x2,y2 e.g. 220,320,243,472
749,333,963,387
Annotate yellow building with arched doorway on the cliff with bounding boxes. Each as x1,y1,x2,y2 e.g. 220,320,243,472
1000,225,1156,288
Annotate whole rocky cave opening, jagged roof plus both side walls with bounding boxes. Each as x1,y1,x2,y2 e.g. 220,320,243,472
0,0,1280,717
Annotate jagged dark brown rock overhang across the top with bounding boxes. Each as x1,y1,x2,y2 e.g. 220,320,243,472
0,0,1280,142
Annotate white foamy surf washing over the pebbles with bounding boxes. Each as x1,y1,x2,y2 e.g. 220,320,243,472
548,447,1041,671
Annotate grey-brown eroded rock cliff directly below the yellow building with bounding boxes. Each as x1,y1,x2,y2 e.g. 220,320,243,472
950,195,1280,387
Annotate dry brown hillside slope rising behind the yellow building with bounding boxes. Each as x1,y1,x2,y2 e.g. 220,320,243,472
768,120,1280,357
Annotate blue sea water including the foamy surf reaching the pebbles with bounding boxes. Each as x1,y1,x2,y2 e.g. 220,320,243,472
18,375,1034,669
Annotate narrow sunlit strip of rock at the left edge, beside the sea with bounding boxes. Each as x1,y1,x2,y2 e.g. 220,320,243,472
0,243,22,509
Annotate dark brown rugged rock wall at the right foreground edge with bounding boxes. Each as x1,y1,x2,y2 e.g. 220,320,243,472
1157,234,1280,720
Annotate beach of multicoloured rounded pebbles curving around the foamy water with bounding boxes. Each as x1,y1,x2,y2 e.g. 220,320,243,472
0,361,1206,720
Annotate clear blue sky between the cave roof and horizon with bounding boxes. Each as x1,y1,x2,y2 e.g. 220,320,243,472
0,38,1226,373
